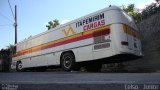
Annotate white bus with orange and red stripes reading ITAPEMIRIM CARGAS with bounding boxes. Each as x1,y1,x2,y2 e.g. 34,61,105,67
11,6,142,71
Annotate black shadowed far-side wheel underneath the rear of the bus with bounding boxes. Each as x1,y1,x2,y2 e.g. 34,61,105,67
85,64,102,72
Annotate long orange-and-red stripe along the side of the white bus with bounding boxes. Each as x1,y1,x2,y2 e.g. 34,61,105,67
13,26,110,57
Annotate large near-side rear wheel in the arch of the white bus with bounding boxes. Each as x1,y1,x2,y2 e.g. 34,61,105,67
61,52,75,71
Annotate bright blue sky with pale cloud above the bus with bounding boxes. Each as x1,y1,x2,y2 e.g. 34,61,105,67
0,0,154,49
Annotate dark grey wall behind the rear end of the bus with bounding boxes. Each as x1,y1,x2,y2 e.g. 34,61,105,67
125,13,160,71
